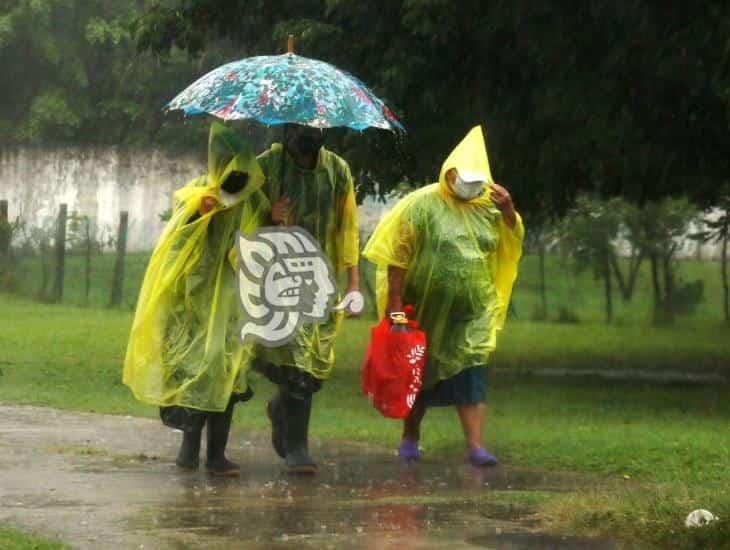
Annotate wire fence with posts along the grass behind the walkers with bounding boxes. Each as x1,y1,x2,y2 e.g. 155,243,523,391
0,200,727,323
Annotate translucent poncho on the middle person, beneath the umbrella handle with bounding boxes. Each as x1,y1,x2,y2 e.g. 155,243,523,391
256,143,360,380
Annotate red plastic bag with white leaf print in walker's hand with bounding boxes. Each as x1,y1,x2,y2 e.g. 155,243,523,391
361,308,426,418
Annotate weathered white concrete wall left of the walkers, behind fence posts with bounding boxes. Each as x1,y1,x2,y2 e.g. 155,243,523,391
0,147,205,251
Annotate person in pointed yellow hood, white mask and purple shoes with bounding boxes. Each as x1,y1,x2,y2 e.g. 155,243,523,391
363,126,524,466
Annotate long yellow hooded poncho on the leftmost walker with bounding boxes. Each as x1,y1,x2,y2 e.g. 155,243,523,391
123,123,269,411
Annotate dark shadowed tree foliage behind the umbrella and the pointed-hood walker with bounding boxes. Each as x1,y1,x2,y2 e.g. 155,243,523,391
129,0,730,212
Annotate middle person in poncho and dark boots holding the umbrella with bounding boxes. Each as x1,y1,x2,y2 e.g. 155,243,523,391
255,124,362,474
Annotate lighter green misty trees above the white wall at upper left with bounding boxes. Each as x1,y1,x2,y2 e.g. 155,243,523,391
0,0,230,146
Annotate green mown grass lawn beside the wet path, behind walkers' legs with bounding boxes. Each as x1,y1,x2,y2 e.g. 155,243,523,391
0,295,730,548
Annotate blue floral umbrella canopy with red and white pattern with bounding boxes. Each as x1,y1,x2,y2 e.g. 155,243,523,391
166,53,405,131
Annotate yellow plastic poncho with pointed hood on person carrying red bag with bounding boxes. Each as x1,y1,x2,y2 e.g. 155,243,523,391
363,127,524,389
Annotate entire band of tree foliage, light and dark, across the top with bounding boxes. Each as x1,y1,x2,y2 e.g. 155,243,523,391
0,0,730,216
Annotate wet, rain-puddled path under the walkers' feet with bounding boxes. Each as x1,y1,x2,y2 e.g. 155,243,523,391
0,406,611,550
